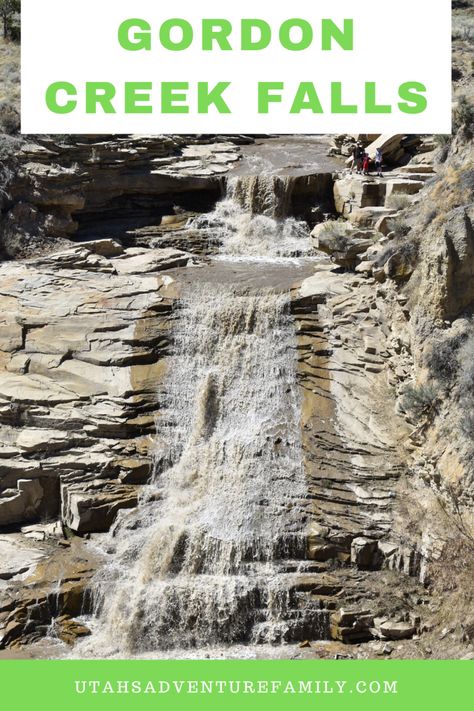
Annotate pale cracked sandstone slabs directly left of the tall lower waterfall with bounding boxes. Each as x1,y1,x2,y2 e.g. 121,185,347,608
0,242,183,533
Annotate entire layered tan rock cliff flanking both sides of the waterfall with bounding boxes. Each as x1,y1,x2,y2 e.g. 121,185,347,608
0,126,473,656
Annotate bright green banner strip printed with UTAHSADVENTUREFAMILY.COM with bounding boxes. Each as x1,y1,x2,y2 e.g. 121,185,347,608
0,660,473,711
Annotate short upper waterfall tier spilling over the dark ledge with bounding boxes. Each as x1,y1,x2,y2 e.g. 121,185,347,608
190,175,313,260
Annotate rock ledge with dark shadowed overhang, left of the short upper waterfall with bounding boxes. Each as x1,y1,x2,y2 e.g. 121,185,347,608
0,136,248,257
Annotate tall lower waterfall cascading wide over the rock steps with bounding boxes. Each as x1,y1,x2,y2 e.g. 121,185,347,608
78,282,328,656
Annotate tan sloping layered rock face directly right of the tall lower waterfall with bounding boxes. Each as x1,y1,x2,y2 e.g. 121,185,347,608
294,268,405,568
